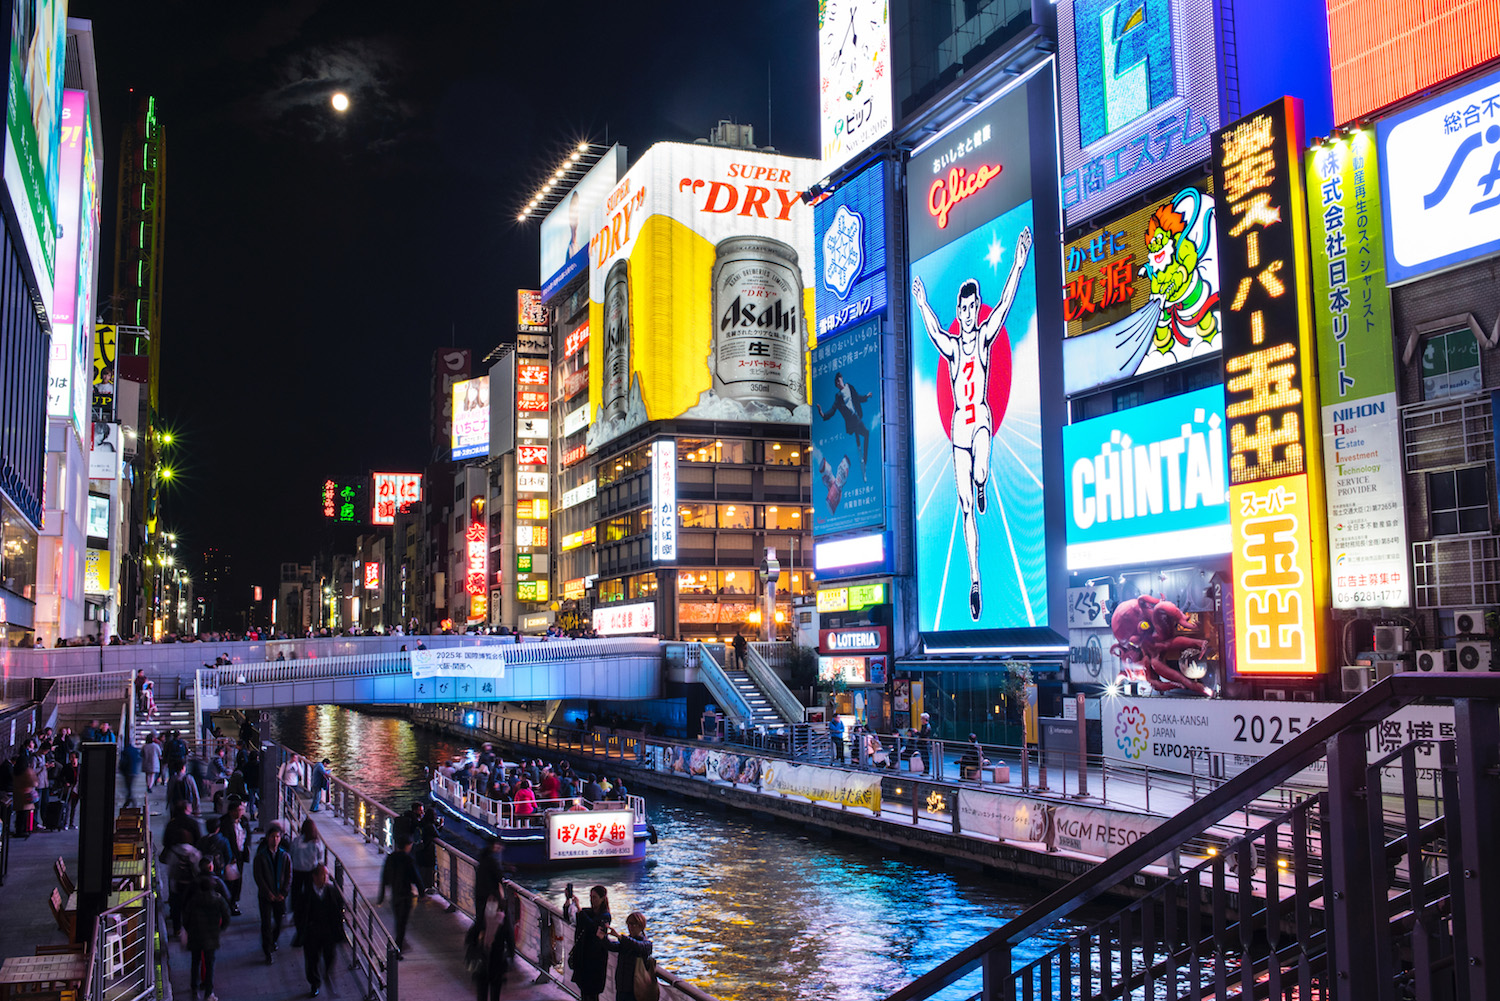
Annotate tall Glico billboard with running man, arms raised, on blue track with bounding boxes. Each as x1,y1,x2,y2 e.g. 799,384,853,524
906,63,1065,642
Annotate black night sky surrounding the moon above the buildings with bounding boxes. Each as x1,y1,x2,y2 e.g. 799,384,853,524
69,0,818,624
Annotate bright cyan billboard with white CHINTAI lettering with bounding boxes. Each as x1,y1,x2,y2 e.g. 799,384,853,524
1062,386,1230,570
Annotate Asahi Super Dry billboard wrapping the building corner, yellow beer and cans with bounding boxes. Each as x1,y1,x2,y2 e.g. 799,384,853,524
588,143,818,453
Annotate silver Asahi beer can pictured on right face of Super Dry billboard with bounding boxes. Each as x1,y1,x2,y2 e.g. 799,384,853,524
710,236,807,410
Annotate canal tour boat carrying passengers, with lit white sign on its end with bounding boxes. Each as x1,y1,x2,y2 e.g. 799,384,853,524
431,774,657,869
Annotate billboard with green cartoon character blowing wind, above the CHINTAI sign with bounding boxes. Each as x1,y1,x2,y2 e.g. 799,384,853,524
1062,177,1223,396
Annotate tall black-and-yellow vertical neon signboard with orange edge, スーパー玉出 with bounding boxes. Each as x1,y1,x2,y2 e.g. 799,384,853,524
1214,98,1328,675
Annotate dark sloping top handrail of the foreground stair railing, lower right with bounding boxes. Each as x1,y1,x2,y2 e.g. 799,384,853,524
885,674,1500,1001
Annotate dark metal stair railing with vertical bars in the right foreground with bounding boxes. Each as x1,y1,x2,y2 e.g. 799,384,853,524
888,674,1500,1001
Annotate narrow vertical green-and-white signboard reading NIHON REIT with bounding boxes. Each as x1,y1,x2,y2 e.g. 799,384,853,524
1307,129,1412,608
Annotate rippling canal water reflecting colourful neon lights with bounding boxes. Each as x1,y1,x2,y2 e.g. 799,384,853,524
270,705,1092,1001
